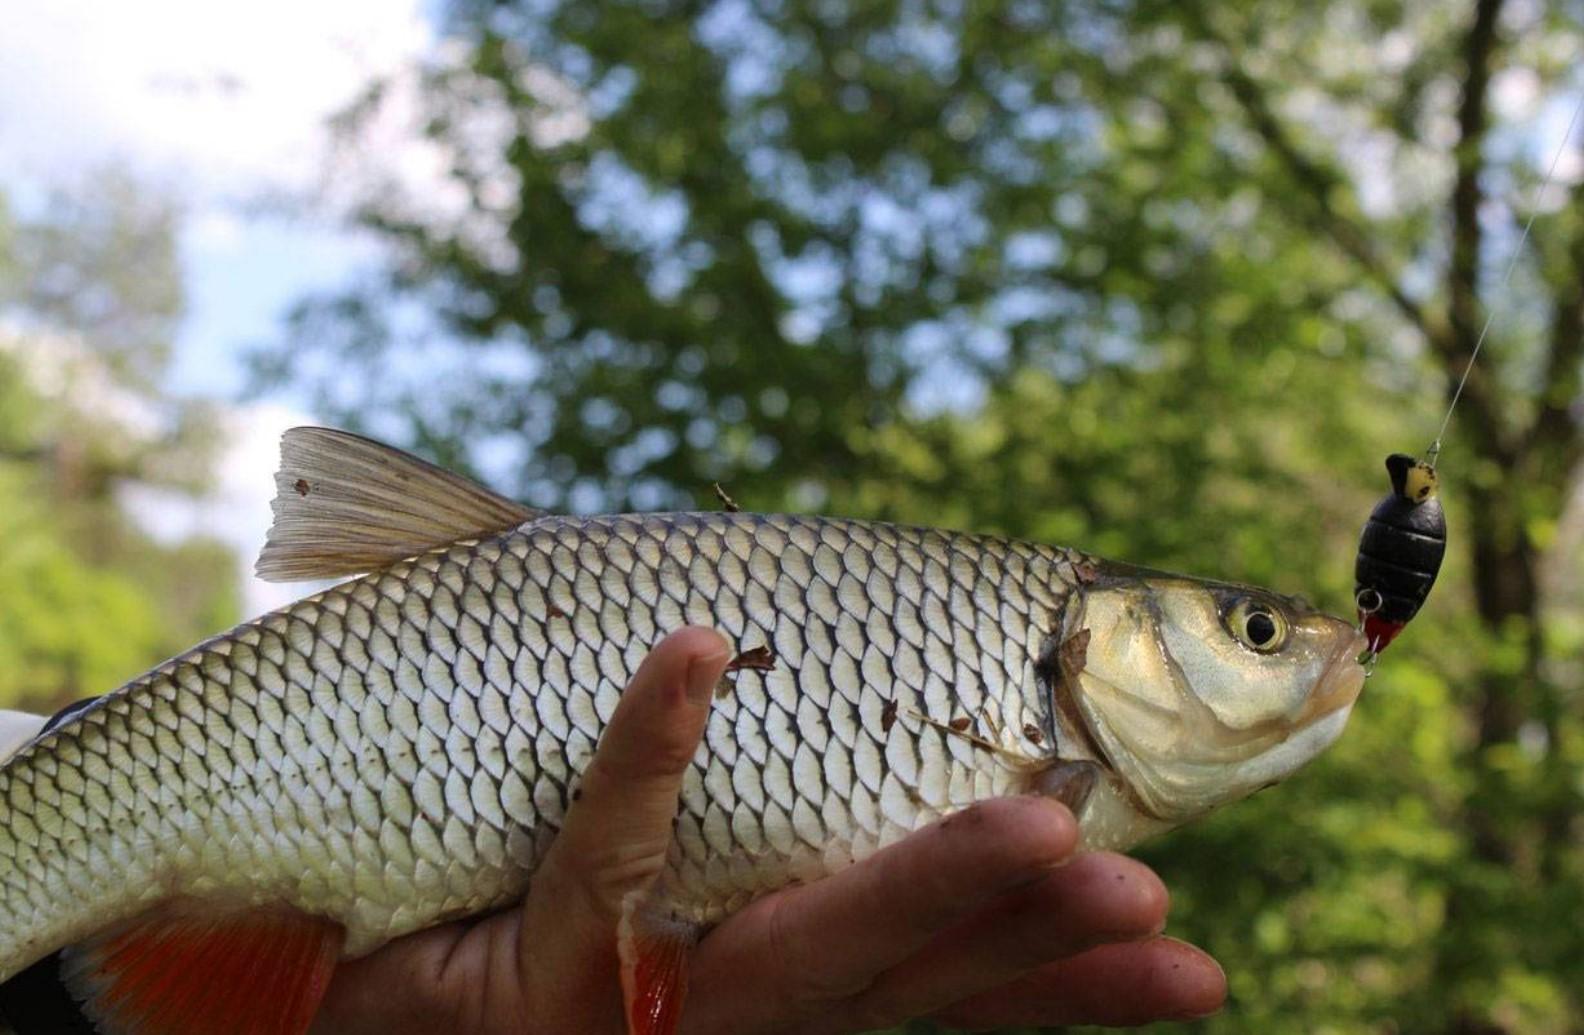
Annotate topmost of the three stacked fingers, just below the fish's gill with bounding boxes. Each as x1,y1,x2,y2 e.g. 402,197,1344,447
684,797,1077,1032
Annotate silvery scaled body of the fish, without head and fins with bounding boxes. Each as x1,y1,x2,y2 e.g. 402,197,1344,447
0,514,1090,978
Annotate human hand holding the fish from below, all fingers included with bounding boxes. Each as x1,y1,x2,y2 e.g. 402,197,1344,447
314,628,1226,1035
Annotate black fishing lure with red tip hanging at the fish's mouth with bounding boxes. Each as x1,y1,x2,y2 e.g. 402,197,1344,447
1353,453,1446,655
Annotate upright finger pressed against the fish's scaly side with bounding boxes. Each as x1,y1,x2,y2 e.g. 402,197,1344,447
520,628,730,1005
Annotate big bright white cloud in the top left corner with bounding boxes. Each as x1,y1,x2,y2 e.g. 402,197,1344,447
0,0,432,198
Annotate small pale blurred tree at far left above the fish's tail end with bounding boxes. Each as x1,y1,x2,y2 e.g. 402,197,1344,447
0,173,238,710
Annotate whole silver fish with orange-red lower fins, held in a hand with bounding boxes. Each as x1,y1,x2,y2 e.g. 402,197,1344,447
0,428,1364,1035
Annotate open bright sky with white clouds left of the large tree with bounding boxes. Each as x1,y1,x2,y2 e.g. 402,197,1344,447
0,0,436,612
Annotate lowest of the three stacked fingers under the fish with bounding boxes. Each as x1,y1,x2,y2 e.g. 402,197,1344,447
931,938,1226,1030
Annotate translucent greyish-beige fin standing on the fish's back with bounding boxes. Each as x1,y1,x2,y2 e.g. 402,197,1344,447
255,428,543,582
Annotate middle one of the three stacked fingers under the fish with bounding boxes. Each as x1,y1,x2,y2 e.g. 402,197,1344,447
832,853,1171,1030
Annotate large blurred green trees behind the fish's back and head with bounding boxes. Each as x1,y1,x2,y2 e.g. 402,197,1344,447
260,0,1584,1032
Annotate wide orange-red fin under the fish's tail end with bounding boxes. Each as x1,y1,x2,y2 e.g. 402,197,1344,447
60,902,345,1035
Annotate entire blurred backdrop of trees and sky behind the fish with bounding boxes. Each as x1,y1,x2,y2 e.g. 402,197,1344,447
0,0,1584,1035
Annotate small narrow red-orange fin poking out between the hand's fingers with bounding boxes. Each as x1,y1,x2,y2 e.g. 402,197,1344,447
616,896,699,1035
